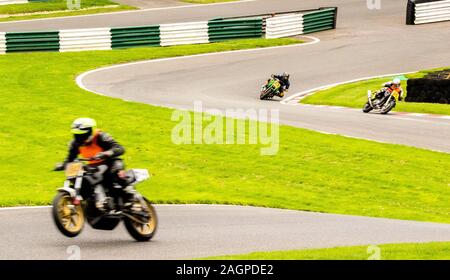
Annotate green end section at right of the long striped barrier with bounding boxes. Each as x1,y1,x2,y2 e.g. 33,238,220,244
303,8,337,34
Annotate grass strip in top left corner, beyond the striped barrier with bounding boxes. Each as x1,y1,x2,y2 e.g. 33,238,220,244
0,0,135,21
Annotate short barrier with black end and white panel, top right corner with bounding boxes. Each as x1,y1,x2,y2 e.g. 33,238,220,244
406,0,450,24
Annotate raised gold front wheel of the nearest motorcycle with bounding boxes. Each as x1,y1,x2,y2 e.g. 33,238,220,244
52,192,85,237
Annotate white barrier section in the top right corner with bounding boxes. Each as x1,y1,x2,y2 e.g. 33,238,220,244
414,0,450,24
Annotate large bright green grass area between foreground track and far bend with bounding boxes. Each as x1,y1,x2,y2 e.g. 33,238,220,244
0,39,450,223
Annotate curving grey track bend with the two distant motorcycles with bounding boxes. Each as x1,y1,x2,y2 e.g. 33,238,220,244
78,1,450,152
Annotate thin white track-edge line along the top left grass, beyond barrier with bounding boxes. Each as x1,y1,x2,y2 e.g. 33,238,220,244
0,0,258,25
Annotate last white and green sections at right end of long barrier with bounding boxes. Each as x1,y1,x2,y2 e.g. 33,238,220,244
266,8,337,38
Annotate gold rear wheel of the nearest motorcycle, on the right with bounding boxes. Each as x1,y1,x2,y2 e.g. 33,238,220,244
124,198,158,241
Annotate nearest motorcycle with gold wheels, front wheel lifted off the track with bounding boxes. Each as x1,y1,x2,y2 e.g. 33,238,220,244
52,158,158,241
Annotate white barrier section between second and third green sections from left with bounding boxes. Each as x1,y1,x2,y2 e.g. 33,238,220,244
159,21,209,46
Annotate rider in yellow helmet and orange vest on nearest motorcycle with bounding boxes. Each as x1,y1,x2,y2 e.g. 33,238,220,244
54,118,132,210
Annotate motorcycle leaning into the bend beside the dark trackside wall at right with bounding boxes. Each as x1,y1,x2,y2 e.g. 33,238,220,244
363,88,400,114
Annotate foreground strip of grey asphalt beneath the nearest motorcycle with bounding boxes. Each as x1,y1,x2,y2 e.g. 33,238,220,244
0,205,450,259
